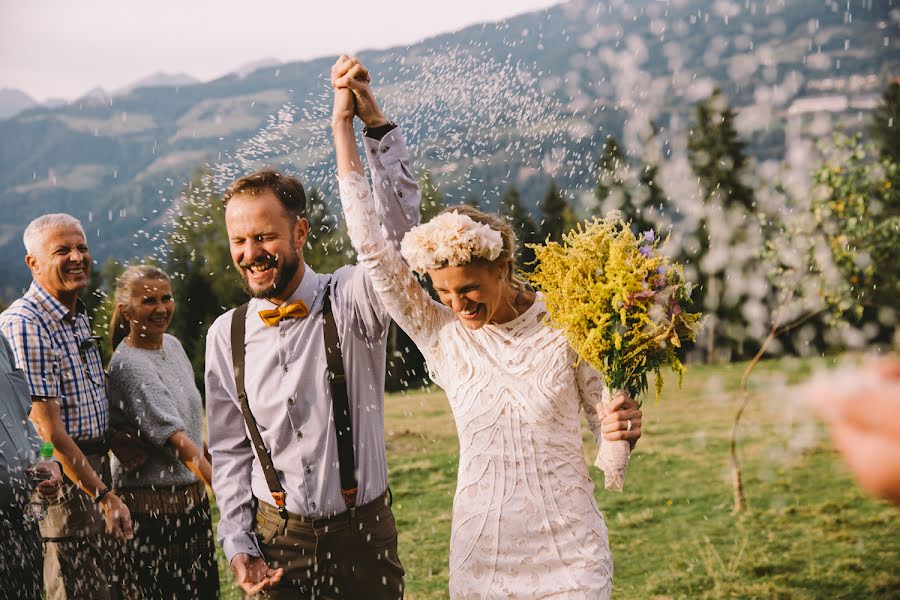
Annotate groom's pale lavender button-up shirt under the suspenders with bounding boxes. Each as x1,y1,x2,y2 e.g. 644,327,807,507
206,129,420,561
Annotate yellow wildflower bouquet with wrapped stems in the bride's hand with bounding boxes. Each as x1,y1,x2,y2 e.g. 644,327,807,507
528,213,700,490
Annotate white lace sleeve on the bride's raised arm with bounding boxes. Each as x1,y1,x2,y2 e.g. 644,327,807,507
338,173,448,358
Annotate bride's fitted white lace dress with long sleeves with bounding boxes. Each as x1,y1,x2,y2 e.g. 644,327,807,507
340,174,612,600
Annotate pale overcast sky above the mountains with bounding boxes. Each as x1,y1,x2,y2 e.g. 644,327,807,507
0,0,561,101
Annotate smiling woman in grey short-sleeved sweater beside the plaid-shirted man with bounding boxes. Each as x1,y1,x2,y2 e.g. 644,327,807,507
109,265,219,600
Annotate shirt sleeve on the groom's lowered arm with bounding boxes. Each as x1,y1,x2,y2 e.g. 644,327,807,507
205,311,262,563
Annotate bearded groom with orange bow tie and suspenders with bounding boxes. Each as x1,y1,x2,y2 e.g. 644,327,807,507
206,56,420,600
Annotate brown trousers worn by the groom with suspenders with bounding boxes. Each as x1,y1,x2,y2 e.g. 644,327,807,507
256,493,404,600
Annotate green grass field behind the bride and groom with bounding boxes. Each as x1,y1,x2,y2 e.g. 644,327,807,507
213,359,900,600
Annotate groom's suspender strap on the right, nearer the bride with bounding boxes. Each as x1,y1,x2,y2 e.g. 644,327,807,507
322,285,359,508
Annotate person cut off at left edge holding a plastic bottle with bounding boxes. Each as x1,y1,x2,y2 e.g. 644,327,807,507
0,335,62,600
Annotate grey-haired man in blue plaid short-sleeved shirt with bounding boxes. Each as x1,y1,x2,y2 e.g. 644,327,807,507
0,214,131,600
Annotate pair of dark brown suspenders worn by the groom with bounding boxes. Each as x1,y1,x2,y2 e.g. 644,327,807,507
231,285,358,522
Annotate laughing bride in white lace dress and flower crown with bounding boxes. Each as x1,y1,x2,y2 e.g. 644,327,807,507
332,57,641,600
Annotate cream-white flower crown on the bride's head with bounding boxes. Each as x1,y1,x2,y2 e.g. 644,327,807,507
400,210,503,273
